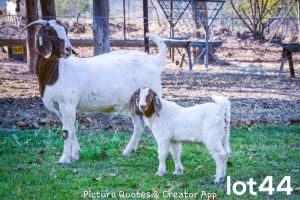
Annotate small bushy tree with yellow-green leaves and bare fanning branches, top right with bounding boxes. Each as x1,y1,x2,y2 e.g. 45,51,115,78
229,0,282,38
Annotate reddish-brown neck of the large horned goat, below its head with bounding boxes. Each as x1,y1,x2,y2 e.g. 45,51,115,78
36,55,58,97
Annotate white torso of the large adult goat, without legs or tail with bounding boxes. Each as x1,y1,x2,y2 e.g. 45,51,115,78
43,51,163,114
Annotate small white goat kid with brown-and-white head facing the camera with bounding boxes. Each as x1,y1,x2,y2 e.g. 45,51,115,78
129,88,230,183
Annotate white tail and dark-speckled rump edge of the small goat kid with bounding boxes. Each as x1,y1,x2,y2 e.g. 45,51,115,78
212,95,231,141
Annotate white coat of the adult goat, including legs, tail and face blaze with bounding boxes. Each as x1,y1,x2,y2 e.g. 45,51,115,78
38,20,167,163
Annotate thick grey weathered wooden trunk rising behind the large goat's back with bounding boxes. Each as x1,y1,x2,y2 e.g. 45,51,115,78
93,0,110,56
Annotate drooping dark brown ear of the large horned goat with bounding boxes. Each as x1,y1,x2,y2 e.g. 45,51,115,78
35,27,52,58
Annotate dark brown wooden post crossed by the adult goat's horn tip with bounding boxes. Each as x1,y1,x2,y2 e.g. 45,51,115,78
25,0,38,73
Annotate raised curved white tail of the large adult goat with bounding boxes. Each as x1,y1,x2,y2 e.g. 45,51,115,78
146,33,168,67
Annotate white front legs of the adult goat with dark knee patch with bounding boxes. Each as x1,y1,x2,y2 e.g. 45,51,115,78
59,105,80,164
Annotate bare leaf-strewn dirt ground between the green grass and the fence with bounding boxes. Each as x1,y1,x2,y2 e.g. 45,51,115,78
0,50,300,131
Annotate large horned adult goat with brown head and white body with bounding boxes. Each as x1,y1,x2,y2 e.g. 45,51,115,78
23,20,167,163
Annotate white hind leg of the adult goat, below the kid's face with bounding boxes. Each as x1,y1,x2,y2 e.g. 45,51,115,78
123,114,145,156
